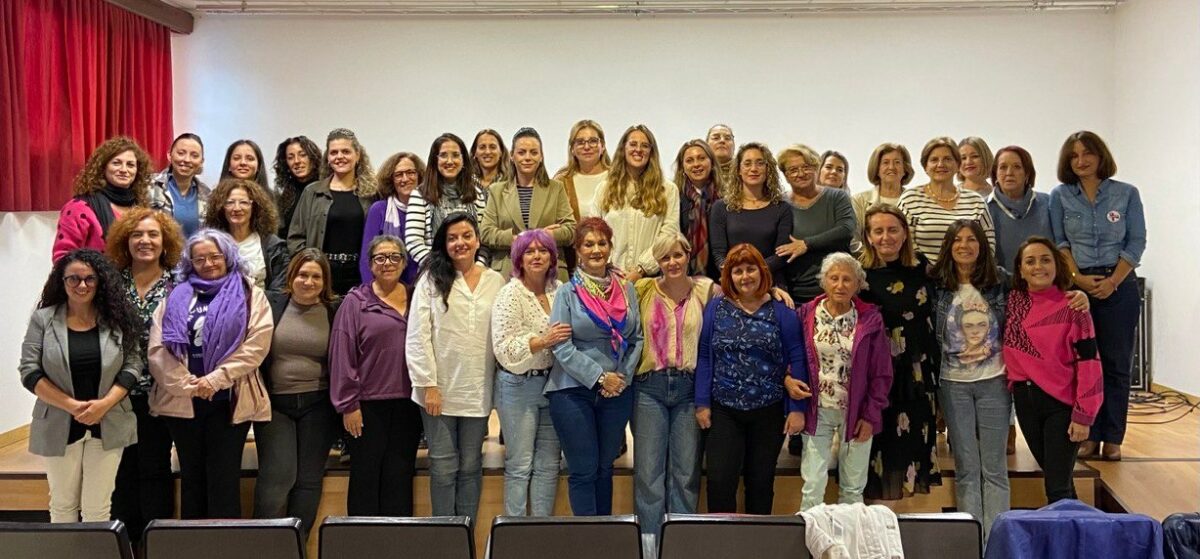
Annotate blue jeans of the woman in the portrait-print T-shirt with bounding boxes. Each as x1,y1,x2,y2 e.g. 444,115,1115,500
941,374,1013,537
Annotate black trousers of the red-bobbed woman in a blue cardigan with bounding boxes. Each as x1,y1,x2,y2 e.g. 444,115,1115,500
704,402,786,515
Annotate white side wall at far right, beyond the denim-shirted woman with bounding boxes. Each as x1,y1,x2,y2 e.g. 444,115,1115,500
1110,0,1200,395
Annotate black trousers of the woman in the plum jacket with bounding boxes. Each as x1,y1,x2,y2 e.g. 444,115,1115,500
346,398,422,516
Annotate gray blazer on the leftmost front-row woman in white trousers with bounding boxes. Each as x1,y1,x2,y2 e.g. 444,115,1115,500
19,305,142,456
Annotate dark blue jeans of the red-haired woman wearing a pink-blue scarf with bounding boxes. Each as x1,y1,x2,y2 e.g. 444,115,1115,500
548,386,634,516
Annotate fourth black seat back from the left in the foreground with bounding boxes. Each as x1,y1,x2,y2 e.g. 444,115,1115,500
488,515,642,559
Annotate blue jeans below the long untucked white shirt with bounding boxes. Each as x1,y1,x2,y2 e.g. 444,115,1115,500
417,409,487,522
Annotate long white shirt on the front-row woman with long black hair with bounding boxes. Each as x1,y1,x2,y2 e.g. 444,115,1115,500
404,263,504,417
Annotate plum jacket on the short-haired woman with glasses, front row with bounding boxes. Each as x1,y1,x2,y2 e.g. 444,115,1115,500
329,283,413,414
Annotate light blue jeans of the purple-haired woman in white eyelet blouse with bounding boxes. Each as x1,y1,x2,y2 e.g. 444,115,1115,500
496,369,562,516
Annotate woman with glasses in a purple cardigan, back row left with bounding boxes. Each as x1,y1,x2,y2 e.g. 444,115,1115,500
359,151,425,287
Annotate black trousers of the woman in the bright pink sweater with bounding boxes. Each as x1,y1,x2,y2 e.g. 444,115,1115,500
1013,380,1079,503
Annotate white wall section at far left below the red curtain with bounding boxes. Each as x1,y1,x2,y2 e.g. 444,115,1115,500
0,212,59,433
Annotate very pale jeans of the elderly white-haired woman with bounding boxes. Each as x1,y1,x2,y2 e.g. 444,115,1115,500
800,402,871,510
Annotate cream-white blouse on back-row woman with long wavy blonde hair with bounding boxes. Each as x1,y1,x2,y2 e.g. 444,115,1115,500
584,180,679,274
